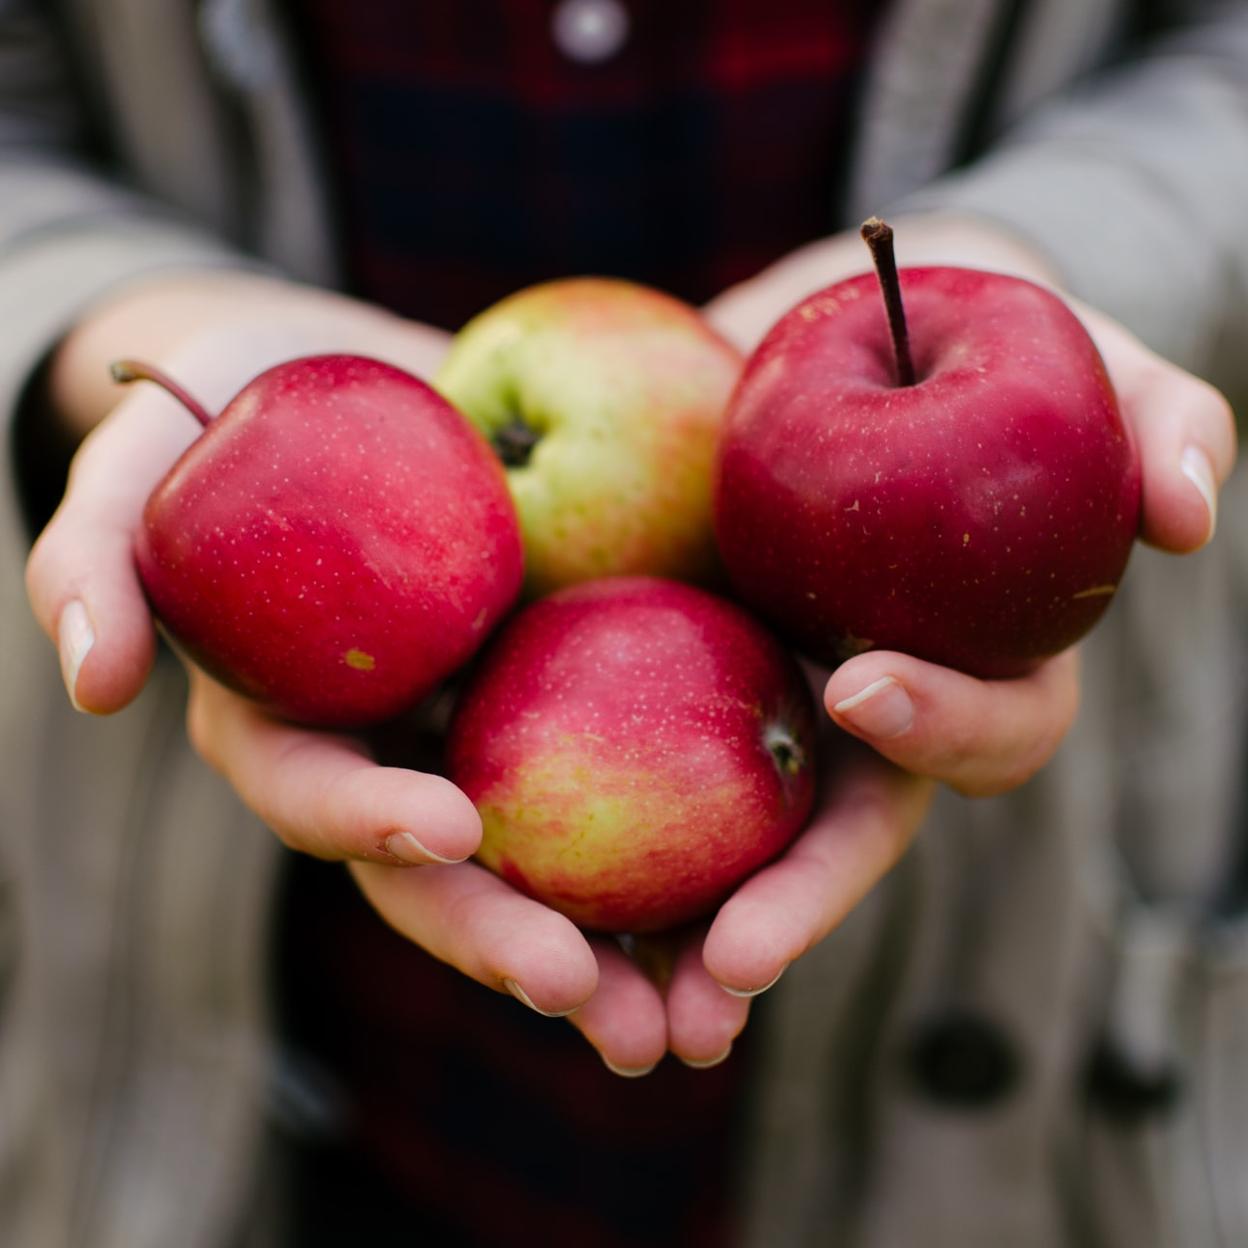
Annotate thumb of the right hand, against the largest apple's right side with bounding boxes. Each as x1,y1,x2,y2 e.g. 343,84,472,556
1082,308,1236,553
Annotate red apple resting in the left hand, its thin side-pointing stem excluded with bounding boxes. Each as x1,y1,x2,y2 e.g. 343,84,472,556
136,356,522,726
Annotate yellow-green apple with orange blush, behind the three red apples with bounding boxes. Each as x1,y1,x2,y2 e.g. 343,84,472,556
434,278,741,597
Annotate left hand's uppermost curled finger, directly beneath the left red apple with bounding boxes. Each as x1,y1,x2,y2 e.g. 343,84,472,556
187,668,480,866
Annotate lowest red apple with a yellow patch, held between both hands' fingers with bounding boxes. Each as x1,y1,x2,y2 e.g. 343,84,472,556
448,578,815,932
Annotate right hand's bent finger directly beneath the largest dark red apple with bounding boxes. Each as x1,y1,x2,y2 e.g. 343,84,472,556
824,649,1080,796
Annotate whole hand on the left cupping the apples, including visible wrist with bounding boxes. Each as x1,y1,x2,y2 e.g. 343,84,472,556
19,275,688,1073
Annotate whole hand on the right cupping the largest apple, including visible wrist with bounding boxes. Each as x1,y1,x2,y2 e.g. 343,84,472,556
665,218,1236,1065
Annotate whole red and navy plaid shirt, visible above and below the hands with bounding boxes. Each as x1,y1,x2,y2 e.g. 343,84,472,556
280,0,879,1248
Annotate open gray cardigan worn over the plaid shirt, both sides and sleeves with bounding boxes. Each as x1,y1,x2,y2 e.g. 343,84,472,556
0,0,1248,1248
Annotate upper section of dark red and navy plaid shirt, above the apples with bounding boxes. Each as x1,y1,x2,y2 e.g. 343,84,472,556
290,0,882,328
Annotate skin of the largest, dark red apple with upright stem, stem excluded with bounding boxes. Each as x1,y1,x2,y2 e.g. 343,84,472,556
715,268,1139,676
